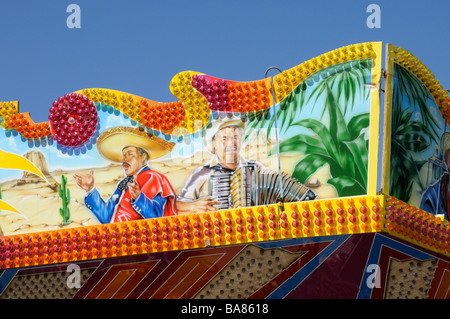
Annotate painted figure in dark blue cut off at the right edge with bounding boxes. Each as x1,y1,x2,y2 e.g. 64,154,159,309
420,132,450,220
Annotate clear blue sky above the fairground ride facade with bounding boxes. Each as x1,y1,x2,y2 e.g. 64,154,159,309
0,0,450,122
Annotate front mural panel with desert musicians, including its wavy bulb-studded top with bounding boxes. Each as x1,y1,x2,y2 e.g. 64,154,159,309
0,43,380,235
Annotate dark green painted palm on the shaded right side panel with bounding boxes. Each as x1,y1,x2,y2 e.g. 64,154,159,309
389,63,439,201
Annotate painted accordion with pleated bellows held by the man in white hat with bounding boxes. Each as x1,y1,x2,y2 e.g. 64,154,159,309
209,163,317,209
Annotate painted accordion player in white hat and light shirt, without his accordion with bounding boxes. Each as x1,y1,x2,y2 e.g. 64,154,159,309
176,114,264,214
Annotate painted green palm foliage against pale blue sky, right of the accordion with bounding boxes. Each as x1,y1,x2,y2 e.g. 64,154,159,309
246,60,371,196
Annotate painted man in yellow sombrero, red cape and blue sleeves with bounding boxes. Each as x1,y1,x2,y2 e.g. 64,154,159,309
74,127,177,223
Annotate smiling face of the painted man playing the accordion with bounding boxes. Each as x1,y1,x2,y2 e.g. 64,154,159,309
212,127,242,167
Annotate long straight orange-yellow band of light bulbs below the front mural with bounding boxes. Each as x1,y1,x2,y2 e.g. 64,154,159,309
0,196,396,269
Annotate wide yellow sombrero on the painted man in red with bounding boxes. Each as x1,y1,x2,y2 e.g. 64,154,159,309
97,126,175,163
